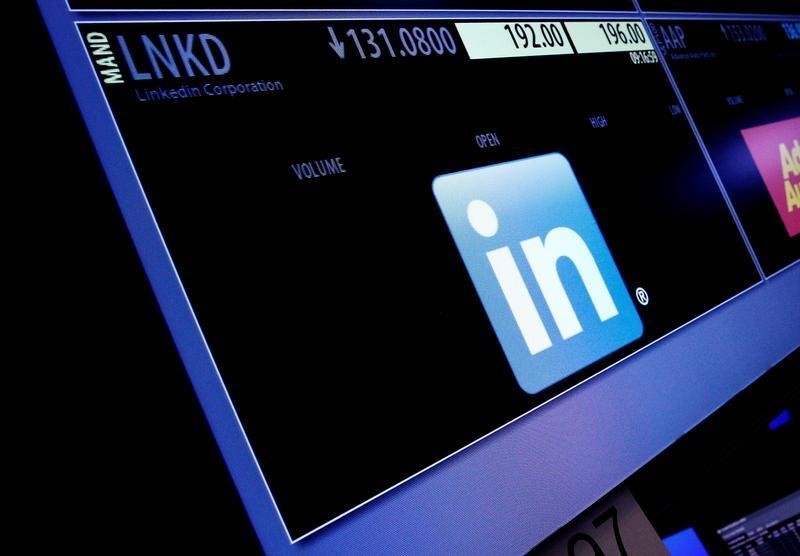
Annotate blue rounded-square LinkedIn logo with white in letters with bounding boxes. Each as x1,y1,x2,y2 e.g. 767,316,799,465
433,153,642,394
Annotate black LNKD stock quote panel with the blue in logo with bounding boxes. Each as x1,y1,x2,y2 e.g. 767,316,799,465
78,19,764,539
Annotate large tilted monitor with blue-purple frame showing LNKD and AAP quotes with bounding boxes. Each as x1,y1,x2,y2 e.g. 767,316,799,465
34,0,800,553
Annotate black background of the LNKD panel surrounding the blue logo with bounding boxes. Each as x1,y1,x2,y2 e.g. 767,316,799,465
87,23,758,536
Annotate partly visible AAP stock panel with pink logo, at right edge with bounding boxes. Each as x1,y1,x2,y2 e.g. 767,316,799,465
650,20,800,275
